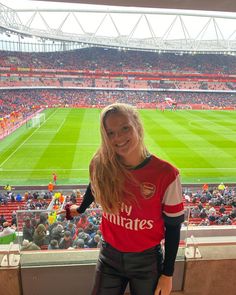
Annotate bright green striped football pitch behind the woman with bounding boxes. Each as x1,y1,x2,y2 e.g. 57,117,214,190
0,108,236,186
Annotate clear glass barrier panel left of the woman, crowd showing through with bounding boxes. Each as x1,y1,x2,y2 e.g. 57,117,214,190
17,199,102,266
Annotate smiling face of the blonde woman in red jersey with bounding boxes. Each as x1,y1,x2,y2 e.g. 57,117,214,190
105,113,141,166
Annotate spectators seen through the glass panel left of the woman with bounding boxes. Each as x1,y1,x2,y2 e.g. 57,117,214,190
17,192,101,250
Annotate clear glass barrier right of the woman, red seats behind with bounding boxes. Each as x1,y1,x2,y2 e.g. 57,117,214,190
181,185,236,258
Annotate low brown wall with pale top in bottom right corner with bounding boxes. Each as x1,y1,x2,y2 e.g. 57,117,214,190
172,245,236,295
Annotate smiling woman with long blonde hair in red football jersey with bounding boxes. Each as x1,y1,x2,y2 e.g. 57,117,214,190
60,104,184,295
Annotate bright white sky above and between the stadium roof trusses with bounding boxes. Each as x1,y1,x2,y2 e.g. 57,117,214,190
0,0,236,40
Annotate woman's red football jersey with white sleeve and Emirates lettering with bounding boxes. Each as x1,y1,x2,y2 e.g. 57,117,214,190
101,155,183,252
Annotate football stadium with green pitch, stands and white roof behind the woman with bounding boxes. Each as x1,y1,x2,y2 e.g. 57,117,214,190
0,1,236,295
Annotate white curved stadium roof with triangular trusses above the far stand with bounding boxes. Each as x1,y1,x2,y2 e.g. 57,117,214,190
0,0,236,54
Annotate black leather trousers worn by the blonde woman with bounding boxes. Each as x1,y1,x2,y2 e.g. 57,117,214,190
91,242,163,295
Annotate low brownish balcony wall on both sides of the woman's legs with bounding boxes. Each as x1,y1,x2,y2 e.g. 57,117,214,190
0,245,236,295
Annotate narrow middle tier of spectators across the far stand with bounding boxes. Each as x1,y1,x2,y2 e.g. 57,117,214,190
0,73,236,92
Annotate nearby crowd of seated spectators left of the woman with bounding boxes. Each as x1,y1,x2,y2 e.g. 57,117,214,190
0,190,101,250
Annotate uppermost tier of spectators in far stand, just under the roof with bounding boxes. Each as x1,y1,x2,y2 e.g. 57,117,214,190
0,48,236,74
